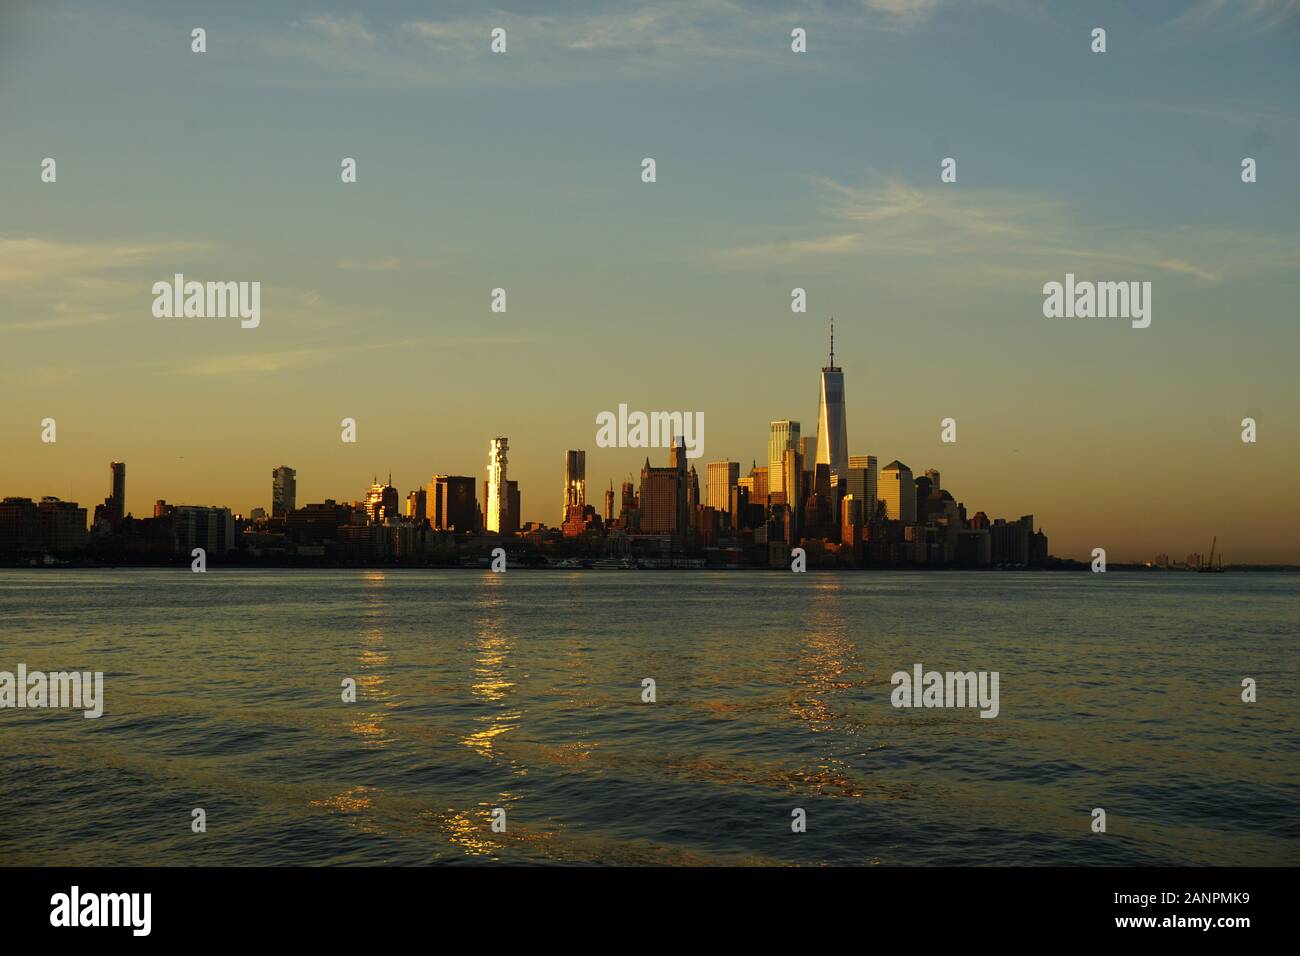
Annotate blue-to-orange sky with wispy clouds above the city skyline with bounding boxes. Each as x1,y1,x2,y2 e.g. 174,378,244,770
0,0,1300,563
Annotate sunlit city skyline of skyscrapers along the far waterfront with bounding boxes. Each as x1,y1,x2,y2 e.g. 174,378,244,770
4,329,1252,567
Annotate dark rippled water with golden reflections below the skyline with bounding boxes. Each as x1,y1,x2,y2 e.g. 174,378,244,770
0,570,1300,865
